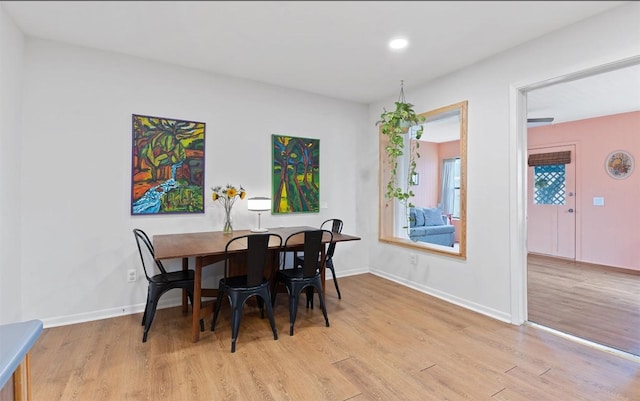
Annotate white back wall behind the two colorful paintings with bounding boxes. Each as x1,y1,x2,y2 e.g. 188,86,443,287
20,39,367,326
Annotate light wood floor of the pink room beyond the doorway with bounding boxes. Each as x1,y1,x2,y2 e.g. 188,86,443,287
527,255,640,354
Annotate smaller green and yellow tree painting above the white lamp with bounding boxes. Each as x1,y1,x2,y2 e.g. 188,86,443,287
272,135,320,214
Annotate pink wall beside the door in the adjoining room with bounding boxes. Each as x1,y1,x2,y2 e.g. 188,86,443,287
527,111,640,270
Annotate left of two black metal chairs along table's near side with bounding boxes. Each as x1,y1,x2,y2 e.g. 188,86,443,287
211,233,282,352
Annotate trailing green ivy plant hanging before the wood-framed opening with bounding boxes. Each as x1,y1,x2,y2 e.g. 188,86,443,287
376,100,424,207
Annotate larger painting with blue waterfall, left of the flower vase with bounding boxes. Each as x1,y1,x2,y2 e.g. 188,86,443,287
131,114,205,215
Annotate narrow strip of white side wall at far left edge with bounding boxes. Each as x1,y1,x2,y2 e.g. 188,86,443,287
0,6,24,324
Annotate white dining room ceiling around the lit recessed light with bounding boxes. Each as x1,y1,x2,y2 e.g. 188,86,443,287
0,1,638,121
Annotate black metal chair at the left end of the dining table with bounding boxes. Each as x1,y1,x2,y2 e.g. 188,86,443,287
133,228,204,343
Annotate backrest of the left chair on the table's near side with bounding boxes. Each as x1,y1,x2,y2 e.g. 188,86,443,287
224,233,282,287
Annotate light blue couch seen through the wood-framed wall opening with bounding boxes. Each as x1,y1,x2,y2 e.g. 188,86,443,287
409,207,456,246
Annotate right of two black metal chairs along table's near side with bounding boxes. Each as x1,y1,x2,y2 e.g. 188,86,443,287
271,230,333,336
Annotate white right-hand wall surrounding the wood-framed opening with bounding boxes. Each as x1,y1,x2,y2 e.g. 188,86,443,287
359,3,640,321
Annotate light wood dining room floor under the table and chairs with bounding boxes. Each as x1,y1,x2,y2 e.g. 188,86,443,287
31,274,640,401
